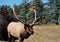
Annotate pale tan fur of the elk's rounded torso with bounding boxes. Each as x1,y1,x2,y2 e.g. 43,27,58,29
7,22,25,38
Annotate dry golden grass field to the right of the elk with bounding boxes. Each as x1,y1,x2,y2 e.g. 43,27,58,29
0,24,60,42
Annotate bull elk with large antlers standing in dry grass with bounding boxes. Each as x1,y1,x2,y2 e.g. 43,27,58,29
7,7,37,42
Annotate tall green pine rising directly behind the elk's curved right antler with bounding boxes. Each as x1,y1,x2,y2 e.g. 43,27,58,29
30,0,44,23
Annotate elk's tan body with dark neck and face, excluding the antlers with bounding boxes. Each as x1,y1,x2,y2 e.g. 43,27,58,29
7,22,33,40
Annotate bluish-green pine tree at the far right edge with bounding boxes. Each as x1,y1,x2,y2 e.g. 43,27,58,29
48,0,60,24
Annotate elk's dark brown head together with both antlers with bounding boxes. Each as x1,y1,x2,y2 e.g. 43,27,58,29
13,7,38,35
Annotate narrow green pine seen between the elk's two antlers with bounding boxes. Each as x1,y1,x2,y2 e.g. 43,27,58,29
19,0,29,23
